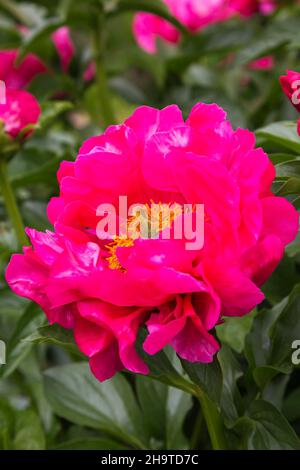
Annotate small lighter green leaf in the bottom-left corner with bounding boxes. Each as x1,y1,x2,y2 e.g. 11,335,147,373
13,409,46,450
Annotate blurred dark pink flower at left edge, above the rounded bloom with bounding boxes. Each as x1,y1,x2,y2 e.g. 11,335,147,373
0,49,47,89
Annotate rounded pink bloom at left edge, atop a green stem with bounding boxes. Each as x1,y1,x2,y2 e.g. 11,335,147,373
0,89,41,138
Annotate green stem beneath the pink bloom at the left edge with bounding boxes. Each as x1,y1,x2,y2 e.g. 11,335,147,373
0,157,28,246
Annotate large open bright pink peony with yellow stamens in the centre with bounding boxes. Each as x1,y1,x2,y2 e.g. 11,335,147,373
6,103,299,380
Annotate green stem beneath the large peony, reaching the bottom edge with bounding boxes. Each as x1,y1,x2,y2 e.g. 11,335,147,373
197,389,227,450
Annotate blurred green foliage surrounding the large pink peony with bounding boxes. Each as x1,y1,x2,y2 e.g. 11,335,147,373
0,0,300,449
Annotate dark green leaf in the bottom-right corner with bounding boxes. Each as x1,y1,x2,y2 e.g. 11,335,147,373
234,400,300,450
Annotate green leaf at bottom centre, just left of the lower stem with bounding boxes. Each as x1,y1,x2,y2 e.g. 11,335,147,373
136,376,192,449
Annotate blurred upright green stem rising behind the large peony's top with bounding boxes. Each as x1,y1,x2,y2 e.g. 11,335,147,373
94,11,115,127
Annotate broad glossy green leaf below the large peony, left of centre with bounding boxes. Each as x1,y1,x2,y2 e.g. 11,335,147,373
44,363,147,448
